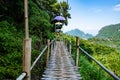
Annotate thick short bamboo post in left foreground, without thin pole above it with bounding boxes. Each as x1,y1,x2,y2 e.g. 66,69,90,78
23,39,31,80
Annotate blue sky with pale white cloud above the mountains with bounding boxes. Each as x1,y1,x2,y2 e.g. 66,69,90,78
61,0,120,36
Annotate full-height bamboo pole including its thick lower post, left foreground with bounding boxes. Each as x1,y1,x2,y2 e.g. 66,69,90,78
22,0,31,80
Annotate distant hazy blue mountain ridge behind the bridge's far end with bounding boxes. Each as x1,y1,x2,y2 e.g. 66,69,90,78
66,29,93,39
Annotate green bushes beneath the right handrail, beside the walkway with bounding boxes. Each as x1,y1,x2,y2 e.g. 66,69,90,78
79,55,112,80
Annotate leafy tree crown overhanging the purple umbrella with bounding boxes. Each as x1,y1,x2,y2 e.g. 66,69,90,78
33,0,71,25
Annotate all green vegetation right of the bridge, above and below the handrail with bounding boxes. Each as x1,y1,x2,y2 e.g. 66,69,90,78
66,36,120,80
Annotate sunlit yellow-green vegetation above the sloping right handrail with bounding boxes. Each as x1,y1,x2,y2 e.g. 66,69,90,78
81,38,120,76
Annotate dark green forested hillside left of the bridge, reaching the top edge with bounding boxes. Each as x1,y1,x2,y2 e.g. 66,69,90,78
0,0,70,80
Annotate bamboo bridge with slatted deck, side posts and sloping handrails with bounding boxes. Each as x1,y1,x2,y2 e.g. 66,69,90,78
16,37,120,80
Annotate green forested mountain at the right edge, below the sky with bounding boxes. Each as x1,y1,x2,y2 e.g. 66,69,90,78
96,23,120,39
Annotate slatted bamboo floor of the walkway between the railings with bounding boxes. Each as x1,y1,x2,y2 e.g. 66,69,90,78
41,42,81,80
